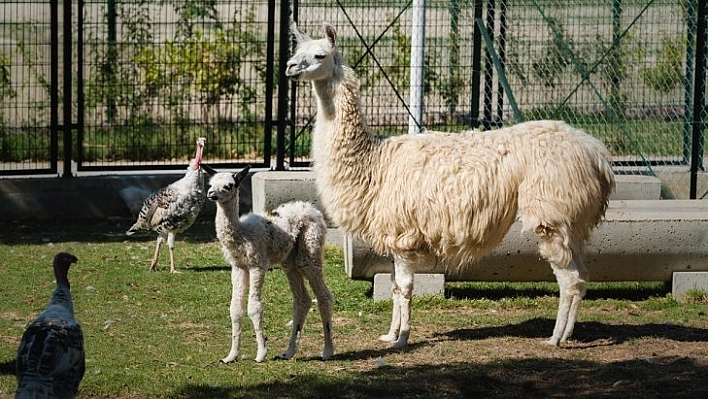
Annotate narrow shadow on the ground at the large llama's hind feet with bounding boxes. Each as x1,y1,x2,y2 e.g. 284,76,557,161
434,318,708,346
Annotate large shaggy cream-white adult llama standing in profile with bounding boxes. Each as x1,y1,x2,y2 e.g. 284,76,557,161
286,24,615,347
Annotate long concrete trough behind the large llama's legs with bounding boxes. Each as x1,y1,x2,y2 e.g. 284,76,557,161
344,200,708,281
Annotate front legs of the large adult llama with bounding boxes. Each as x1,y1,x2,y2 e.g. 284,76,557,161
379,257,414,348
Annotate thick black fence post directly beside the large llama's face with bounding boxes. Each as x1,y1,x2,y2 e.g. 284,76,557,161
275,0,290,170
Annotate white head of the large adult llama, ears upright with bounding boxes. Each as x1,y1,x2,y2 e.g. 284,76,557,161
285,22,343,81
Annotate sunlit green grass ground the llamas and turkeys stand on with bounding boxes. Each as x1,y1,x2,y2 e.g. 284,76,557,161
0,220,708,398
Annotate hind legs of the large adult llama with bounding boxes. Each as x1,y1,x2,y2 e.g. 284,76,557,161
536,226,588,346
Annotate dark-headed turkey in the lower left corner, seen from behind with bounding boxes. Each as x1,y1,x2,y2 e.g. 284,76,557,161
16,252,85,398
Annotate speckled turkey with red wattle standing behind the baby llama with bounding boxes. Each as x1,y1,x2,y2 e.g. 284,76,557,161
125,137,206,273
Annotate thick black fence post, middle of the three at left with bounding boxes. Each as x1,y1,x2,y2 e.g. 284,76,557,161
61,0,73,178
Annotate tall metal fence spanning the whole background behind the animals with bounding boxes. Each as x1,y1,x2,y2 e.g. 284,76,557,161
0,0,708,198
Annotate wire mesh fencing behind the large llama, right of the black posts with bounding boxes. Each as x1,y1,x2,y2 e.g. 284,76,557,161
296,0,708,198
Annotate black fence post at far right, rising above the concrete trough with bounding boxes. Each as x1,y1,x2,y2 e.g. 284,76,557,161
689,0,707,199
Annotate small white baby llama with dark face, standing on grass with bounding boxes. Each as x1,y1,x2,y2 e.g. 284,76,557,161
207,167,334,363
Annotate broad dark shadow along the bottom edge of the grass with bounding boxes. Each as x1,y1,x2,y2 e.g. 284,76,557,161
175,357,708,399
